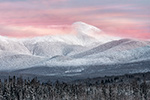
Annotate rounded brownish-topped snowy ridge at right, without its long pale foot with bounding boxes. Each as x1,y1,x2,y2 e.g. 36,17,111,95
75,39,150,63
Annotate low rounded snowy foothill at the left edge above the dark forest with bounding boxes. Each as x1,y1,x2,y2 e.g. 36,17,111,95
0,54,45,70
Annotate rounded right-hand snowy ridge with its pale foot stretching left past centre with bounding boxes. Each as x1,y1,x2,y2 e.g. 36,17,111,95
41,39,150,66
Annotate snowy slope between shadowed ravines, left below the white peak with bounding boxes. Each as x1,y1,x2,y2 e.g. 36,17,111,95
25,42,85,57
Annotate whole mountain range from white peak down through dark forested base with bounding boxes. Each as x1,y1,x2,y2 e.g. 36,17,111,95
0,22,150,80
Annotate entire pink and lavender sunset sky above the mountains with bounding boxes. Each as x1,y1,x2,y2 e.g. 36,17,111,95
0,0,150,39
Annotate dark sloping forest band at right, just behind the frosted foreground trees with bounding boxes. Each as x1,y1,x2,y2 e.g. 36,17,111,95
73,72,150,84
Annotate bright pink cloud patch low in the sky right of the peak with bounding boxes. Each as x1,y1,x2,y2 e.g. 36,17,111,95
104,25,150,39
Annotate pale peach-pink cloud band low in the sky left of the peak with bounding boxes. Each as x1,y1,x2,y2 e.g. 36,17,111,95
0,25,71,38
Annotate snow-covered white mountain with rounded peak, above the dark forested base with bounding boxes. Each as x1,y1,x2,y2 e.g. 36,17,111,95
0,22,150,79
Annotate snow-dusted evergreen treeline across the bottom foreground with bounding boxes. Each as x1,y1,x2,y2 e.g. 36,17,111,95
0,74,150,100
